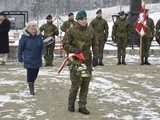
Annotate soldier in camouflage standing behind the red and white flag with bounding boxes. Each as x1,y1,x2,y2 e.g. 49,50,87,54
141,9,154,65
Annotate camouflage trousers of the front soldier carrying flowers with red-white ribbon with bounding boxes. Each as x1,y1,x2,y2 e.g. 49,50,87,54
68,64,91,108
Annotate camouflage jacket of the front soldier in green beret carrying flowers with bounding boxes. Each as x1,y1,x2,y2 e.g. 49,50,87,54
63,23,95,62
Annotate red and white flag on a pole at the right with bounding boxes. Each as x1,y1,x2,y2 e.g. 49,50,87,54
134,1,148,36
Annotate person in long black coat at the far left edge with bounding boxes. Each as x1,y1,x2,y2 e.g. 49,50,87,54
0,12,10,65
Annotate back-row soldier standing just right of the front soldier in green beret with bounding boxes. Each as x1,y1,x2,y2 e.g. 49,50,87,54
90,9,108,66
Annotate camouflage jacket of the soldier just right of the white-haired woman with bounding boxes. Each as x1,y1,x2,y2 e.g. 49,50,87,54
40,23,59,38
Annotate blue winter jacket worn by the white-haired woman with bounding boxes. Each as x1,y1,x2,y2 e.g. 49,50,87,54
18,31,43,68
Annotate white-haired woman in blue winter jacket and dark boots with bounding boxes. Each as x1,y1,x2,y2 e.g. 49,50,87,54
18,22,43,95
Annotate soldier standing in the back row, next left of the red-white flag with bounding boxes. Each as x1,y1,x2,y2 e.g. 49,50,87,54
112,11,128,65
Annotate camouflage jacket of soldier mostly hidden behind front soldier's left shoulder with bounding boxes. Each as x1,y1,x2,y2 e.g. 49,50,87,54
61,20,76,32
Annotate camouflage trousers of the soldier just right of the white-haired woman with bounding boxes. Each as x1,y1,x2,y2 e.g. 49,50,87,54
44,43,55,66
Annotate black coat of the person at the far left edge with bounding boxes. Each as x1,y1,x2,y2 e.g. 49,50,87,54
0,19,10,53
